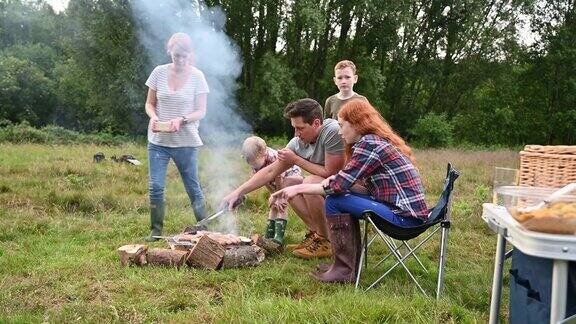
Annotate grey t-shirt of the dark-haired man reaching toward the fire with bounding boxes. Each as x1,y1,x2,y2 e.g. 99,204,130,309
286,118,344,165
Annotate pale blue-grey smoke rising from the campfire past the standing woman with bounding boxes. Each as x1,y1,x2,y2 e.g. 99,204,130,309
131,0,251,232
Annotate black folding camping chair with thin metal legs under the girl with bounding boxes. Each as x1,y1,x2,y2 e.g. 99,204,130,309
356,163,460,298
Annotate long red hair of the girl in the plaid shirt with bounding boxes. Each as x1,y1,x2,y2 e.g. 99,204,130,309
338,99,415,164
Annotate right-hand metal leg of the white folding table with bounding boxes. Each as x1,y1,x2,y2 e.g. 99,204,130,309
550,260,568,324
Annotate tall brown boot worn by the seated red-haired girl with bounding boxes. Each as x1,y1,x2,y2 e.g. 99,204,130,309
310,214,360,283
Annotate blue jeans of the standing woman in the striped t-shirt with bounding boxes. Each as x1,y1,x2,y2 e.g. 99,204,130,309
148,143,206,220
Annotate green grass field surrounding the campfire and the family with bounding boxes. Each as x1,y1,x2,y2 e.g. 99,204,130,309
0,144,518,323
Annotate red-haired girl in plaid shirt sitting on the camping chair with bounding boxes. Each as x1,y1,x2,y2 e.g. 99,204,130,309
272,99,428,283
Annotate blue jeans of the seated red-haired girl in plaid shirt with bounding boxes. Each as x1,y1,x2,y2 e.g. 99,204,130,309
324,193,423,227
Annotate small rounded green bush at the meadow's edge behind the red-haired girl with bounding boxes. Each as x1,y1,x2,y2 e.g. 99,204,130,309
410,112,454,147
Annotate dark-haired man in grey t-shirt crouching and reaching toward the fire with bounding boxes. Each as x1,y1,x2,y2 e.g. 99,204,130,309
222,98,344,259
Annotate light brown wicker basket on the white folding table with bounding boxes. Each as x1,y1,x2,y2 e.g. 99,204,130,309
520,145,576,188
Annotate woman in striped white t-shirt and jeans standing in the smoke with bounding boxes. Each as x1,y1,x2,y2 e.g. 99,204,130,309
146,33,209,241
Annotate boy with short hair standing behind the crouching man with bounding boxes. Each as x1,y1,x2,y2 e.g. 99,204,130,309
324,60,368,120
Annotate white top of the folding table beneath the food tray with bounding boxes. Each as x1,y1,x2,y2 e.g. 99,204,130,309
482,203,576,261
